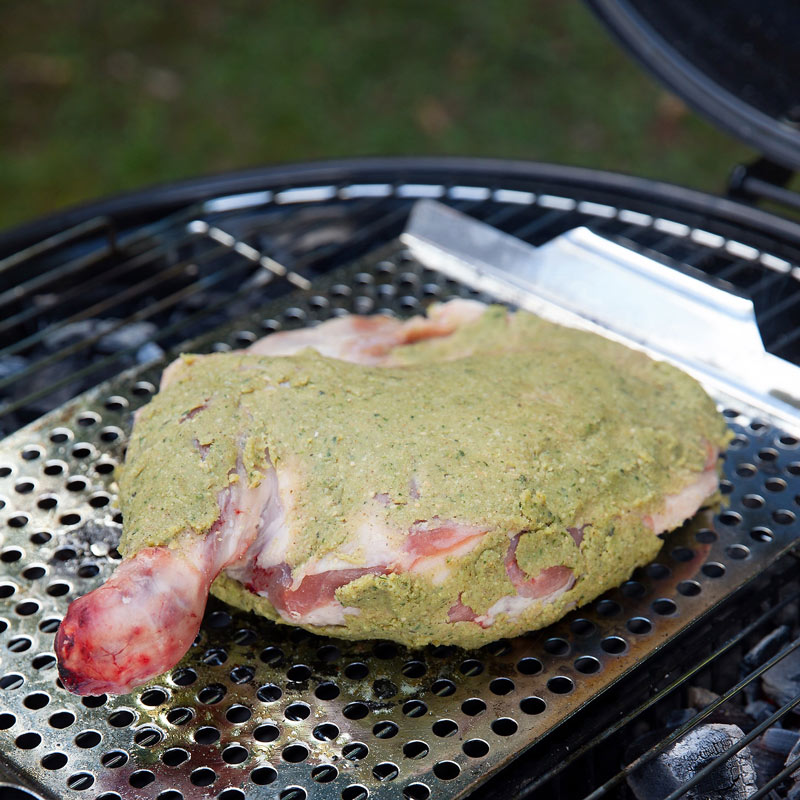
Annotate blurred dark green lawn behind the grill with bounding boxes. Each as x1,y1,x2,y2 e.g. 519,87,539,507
0,0,748,231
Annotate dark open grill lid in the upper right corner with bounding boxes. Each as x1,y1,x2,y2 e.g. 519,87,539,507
588,0,800,169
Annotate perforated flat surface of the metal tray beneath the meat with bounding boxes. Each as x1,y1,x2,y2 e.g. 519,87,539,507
0,246,800,800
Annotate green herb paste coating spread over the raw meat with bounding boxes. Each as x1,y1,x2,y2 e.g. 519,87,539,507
120,306,729,646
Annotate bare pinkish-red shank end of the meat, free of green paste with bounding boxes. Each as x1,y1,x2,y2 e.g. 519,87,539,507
55,454,274,694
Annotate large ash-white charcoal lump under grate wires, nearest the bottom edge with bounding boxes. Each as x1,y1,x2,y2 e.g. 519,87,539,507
628,724,757,800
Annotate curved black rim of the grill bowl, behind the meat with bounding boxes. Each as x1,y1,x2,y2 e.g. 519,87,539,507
0,156,800,258
